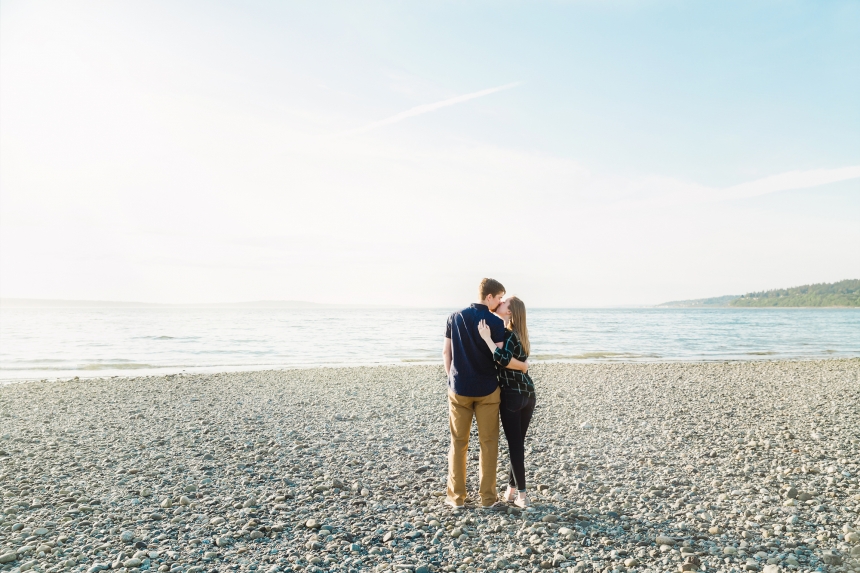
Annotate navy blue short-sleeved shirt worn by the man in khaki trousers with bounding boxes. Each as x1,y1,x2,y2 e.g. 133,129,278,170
445,303,505,397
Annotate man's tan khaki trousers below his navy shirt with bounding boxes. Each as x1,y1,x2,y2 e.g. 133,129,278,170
447,388,500,506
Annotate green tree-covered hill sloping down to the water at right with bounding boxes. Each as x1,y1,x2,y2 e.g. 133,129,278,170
657,280,860,308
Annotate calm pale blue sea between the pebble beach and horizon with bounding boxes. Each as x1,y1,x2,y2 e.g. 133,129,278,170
0,307,860,381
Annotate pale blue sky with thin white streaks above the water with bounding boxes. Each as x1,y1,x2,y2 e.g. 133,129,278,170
0,0,860,307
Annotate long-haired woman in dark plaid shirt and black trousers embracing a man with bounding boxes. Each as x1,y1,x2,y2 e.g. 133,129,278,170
478,296,536,507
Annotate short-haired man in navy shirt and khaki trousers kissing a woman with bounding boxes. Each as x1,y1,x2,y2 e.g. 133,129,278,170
442,279,505,508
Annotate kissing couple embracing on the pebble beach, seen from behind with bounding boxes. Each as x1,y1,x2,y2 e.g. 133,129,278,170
442,279,535,509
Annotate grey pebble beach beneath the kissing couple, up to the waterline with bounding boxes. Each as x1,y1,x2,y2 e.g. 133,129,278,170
0,359,860,573
